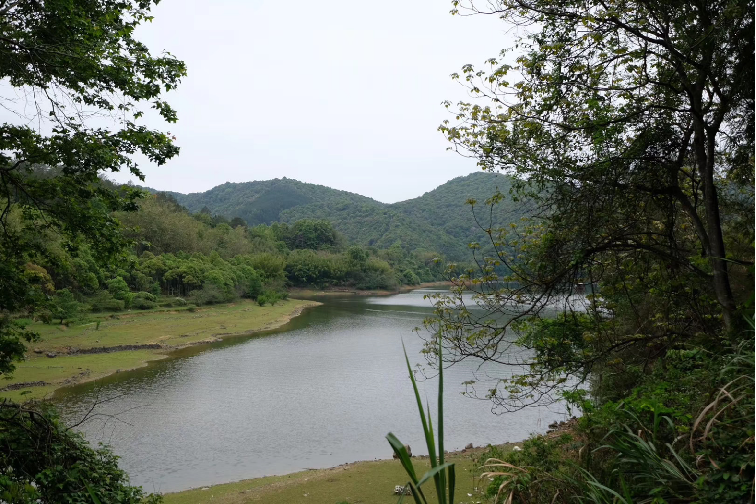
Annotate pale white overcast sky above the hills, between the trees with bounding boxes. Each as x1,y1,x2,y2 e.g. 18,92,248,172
109,0,512,202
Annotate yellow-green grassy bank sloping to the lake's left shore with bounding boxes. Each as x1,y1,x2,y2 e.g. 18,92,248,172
0,299,317,400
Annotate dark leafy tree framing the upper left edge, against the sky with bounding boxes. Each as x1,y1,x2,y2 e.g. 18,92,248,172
0,0,186,373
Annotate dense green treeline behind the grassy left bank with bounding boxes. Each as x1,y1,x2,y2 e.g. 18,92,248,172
27,193,441,321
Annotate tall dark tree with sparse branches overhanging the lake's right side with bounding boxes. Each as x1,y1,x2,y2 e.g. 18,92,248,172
432,0,754,407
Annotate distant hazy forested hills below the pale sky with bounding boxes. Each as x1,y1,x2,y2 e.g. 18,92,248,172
154,172,520,260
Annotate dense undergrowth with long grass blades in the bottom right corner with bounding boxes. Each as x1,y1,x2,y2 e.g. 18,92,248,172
472,334,754,504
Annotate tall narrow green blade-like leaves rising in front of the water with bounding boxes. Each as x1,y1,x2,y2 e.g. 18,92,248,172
386,340,456,504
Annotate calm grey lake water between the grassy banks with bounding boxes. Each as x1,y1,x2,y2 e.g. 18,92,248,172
54,290,563,491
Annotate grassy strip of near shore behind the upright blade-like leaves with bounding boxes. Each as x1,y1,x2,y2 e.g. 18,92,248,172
164,448,510,504
